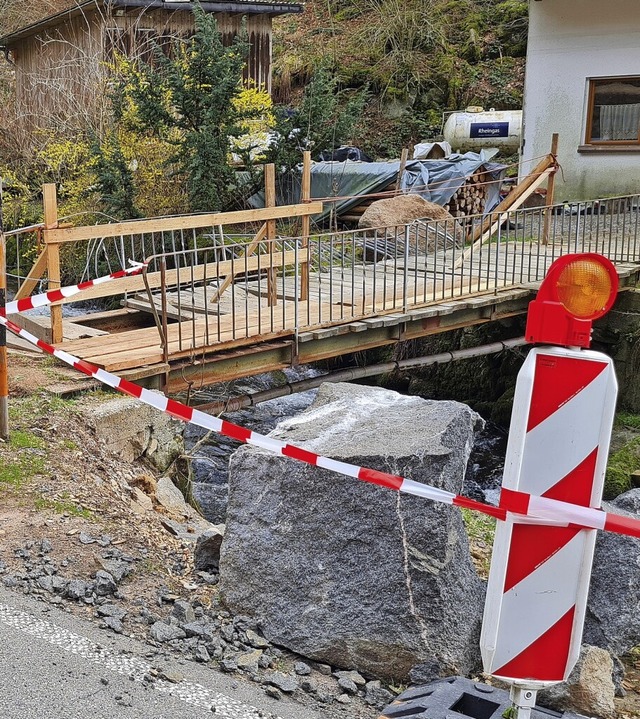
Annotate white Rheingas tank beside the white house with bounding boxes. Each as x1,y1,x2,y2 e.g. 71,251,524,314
443,107,522,153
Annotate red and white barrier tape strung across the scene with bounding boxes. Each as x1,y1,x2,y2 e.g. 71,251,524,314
0,266,640,538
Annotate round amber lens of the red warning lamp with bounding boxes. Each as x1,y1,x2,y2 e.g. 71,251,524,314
557,260,613,320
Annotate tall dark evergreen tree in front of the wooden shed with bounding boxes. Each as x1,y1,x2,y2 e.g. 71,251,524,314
102,4,249,212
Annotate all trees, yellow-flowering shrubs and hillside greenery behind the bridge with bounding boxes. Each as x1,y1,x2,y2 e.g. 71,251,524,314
0,0,528,228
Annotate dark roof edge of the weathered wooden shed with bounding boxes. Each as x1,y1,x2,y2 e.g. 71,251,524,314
0,0,303,48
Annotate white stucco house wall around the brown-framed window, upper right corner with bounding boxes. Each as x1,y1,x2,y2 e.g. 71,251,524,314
521,0,640,201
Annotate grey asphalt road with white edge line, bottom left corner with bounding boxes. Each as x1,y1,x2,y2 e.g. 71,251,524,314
0,587,328,719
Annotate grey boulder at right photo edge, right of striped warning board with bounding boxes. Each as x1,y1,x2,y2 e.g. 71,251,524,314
583,489,640,656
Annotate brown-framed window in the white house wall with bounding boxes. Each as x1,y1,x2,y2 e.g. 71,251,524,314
586,77,640,145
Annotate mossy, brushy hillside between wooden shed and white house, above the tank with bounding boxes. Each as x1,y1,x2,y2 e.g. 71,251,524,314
274,0,528,157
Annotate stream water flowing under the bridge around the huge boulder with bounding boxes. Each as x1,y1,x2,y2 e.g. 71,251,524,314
185,368,507,523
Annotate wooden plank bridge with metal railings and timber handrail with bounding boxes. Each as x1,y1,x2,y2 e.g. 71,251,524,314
6,179,640,393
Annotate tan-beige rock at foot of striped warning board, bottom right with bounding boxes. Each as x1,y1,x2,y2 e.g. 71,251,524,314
539,645,617,719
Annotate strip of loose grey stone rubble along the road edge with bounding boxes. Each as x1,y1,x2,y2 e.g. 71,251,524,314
0,536,394,717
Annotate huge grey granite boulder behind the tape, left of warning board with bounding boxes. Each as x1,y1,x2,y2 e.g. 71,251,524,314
220,384,484,678
